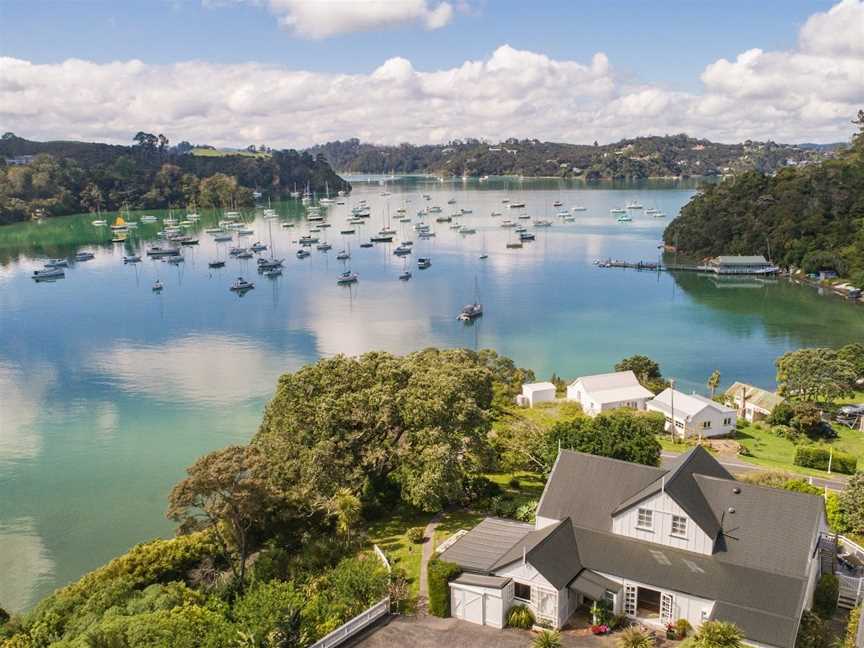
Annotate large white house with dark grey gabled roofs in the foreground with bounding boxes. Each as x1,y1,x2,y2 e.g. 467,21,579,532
441,446,830,648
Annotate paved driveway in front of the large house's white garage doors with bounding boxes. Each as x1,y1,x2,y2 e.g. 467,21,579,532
346,616,613,648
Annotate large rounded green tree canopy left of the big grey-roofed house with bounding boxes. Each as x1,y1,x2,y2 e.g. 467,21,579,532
254,349,528,511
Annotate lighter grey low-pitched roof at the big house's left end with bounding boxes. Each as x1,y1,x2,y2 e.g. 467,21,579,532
440,518,534,574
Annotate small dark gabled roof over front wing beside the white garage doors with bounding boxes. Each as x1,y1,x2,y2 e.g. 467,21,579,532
493,518,582,590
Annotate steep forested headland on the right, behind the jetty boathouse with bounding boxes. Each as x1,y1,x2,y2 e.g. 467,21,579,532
663,116,864,286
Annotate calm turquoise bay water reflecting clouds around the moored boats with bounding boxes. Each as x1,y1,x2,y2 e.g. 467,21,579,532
0,179,864,610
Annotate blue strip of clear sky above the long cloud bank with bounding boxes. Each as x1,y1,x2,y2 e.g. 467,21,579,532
0,0,832,91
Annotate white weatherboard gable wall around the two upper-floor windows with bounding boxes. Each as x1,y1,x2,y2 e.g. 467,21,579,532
612,492,714,556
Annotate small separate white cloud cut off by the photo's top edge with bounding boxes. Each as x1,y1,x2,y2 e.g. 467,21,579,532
216,0,453,39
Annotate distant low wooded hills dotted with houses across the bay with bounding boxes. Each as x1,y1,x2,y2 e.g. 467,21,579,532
308,135,833,179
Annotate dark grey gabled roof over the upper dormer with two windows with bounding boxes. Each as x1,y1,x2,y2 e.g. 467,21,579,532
613,446,734,540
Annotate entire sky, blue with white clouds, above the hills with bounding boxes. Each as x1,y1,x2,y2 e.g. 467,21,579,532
0,0,864,147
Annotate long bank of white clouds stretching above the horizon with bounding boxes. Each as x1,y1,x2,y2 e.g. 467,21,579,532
0,0,864,147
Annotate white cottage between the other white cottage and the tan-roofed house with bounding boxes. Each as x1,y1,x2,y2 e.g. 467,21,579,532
647,387,737,438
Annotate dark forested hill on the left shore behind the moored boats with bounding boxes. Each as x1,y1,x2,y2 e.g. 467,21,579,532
0,133,350,224
